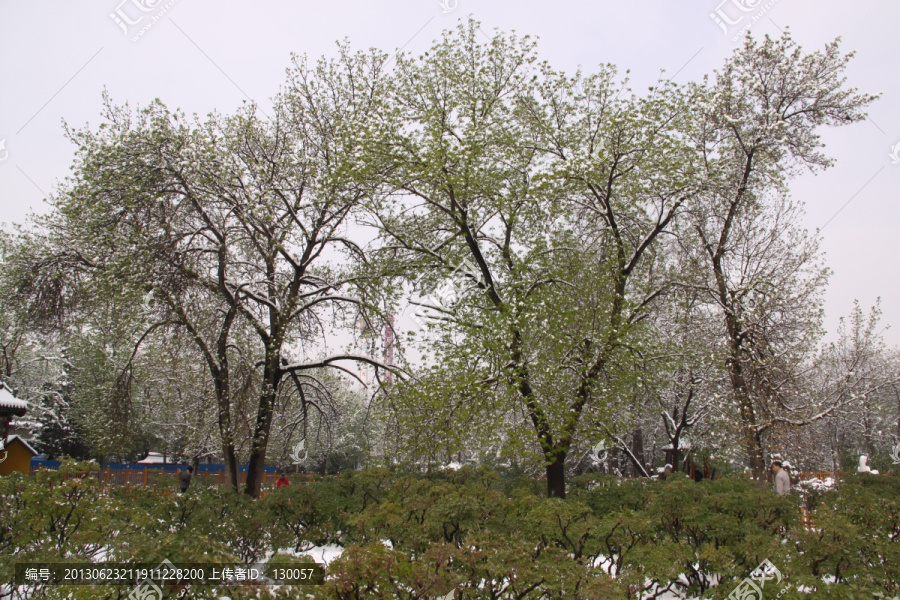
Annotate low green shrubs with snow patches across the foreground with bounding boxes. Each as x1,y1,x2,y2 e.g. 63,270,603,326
0,464,900,600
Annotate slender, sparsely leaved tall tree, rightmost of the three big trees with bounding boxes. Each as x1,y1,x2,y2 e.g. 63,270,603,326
690,34,875,477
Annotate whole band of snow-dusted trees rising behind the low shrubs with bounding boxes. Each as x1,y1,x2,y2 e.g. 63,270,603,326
0,20,900,497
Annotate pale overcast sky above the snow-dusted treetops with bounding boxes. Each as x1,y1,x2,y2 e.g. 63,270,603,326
0,0,900,345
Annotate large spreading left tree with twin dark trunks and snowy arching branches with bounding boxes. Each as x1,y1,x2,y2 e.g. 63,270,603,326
15,49,396,495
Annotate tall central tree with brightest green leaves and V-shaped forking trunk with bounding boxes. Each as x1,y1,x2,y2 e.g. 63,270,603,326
372,21,699,497
